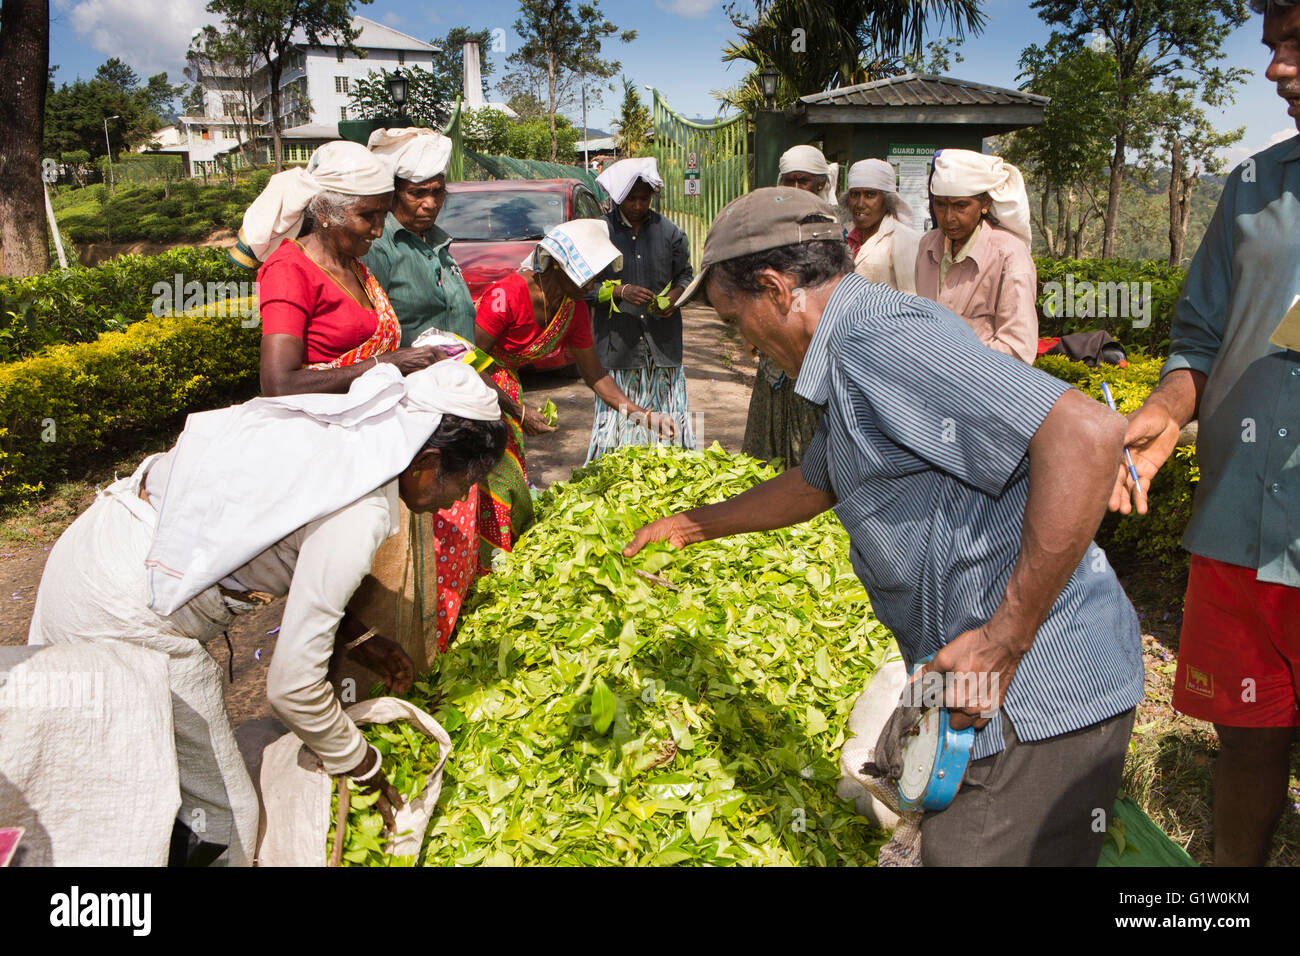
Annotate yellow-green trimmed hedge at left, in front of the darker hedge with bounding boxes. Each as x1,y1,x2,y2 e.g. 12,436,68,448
0,299,260,505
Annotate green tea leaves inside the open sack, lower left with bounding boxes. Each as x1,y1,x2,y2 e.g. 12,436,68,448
325,721,441,866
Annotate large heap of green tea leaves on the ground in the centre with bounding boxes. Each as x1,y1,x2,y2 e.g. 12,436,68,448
412,445,889,865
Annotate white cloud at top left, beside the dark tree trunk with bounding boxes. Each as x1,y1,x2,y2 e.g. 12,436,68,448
65,0,217,83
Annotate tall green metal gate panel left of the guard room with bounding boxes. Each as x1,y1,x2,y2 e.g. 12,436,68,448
653,90,750,269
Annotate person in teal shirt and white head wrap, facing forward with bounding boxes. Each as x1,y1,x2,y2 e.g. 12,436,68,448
361,135,475,349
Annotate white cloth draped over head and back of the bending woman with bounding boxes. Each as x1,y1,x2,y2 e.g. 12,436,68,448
144,360,501,615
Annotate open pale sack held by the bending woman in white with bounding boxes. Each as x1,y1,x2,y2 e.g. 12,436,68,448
257,697,451,866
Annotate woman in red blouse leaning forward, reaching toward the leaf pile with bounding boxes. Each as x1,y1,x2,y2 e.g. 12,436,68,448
475,219,676,564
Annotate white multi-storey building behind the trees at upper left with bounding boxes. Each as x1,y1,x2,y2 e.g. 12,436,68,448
155,17,439,176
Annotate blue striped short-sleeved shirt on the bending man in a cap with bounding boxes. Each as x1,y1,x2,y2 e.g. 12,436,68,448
796,274,1143,758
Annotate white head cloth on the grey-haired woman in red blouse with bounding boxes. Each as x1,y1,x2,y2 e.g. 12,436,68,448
239,139,393,261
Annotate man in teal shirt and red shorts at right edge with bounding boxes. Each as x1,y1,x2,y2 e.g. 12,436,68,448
1110,0,1300,866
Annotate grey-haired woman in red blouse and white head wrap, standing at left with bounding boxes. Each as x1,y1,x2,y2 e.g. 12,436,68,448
240,140,447,395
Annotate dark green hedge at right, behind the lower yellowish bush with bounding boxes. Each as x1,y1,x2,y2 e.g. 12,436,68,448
1034,256,1187,355
